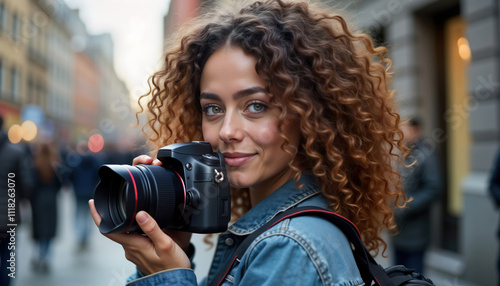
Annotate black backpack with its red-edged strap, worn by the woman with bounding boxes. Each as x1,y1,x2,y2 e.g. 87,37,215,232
210,207,434,286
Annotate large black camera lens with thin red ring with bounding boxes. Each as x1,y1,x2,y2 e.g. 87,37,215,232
94,165,186,233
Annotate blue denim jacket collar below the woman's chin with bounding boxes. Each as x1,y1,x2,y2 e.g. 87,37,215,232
228,173,321,235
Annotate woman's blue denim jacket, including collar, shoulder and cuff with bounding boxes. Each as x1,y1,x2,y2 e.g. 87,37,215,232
127,174,363,286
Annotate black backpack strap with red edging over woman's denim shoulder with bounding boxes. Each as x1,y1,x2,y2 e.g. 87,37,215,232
209,206,394,286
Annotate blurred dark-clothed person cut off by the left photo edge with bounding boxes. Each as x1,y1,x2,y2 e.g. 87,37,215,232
0,115,32,286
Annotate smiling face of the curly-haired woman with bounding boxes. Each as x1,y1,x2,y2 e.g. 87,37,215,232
200,46,300,205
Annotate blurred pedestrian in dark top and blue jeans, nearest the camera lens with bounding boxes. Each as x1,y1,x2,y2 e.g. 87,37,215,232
70,145,100,252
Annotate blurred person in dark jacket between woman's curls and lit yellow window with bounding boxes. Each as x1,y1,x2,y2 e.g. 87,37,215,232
392,117,442,273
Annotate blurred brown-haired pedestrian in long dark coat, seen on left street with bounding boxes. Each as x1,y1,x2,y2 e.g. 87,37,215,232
31,142,62,273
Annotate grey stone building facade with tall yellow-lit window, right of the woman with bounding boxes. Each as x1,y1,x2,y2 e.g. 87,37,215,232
345,0,500,285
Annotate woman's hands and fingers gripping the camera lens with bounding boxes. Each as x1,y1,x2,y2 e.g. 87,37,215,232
89,155,191,275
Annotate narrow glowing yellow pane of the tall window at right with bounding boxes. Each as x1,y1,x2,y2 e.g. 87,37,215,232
443,13,472,250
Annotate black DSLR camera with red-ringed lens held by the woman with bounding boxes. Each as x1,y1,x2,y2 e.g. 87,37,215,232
94,141,231,234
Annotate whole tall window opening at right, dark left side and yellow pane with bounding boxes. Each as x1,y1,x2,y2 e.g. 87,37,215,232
417,3,464,252
